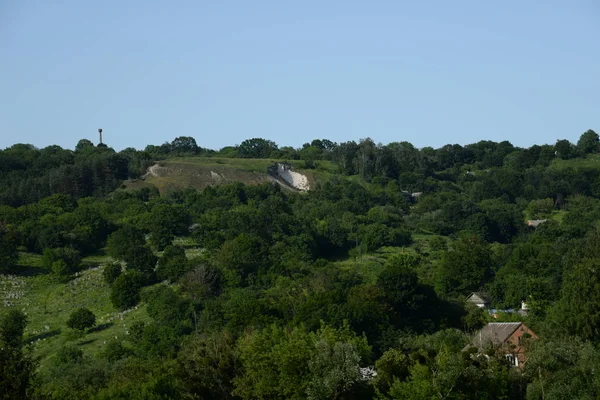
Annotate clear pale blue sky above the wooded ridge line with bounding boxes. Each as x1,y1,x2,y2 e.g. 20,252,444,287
0,0,600,149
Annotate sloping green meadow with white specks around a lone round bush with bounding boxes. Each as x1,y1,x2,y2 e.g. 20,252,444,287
0,253,149,371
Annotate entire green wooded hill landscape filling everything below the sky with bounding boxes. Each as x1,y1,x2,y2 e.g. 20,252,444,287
0,130,600,399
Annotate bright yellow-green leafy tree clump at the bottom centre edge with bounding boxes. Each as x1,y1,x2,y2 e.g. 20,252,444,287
233,324,371,399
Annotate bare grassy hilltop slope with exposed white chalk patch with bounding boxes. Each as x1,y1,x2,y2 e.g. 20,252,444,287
123,157,335,194
